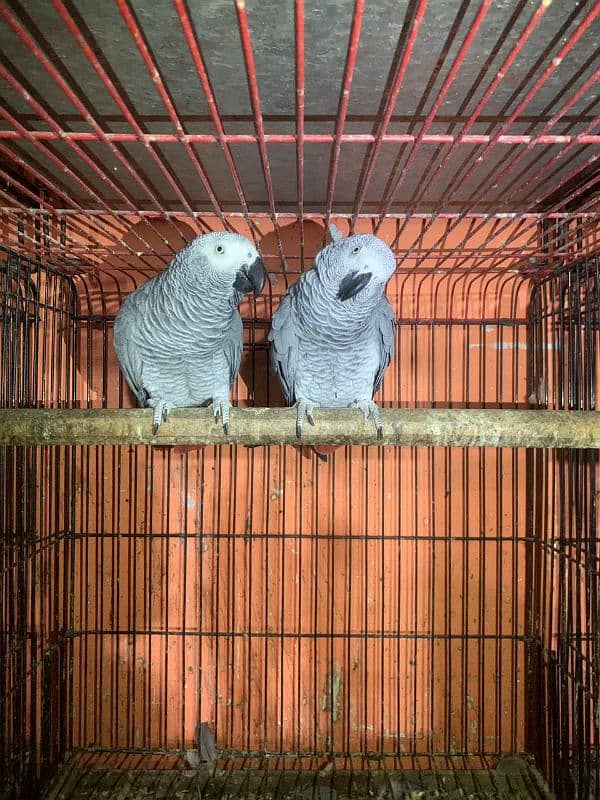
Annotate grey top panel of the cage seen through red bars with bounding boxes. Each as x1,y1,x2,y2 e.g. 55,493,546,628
0,0,600,214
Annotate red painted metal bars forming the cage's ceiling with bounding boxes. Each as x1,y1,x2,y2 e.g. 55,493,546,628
0,0,600,267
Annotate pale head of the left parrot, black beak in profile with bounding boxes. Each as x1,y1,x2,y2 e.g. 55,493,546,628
174,231,267,295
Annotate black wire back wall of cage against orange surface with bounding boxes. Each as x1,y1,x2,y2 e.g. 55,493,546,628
3,242,529,792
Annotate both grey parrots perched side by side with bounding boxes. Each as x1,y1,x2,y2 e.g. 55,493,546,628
114,229,396,437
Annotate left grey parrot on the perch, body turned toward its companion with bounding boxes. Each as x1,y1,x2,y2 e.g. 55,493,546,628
114,232,266,433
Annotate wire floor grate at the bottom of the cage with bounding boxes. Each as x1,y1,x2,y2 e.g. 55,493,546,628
48,753,549,800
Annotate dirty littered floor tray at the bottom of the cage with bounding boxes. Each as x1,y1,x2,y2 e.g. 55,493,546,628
46,757,552,800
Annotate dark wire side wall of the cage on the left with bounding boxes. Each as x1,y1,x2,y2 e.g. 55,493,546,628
0,248,76,796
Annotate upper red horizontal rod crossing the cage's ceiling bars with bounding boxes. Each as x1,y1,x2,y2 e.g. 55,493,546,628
0,129,600,146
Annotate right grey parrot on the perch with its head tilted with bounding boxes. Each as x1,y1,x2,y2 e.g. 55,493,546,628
269,231,396,437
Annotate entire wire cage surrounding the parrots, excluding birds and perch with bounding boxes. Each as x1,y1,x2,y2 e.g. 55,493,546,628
0,0,600,800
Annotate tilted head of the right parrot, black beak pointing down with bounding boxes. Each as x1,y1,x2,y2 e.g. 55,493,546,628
318,233,396,303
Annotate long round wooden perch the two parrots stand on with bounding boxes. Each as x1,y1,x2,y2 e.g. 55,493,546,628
0,408,600,448
